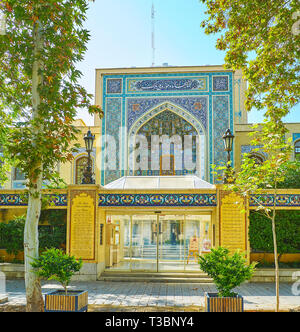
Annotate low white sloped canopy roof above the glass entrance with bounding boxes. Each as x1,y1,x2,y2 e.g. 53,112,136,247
105,175,216,190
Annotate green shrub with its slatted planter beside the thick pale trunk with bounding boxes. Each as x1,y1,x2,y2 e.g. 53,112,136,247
31,248,88,312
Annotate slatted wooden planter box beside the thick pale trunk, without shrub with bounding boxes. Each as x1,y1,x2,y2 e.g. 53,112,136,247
45,290,88,312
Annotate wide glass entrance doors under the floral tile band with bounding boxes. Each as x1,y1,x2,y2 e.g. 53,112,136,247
109,214,212,272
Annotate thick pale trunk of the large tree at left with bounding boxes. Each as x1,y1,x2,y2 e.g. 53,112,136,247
24,21,44,312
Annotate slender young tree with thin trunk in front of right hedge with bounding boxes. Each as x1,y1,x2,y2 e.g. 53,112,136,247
228,123,292,311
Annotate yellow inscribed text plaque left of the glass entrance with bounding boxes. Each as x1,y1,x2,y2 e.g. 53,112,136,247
69,191,96,260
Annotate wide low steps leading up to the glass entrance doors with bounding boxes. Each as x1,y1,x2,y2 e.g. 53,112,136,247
98,271,213,284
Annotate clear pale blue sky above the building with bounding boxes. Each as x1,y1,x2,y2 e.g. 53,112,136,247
78,0,300,125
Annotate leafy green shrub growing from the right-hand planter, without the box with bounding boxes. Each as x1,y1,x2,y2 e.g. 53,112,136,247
199,247,256,297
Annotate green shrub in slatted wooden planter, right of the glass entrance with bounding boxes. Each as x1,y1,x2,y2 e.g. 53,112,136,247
199,247,256,312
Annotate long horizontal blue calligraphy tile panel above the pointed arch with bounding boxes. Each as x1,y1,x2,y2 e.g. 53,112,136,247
127,77,208,93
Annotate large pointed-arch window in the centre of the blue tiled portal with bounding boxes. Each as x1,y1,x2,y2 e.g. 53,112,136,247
134,109,199,176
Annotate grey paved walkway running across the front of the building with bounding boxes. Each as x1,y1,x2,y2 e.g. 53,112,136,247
1,280,300,310
